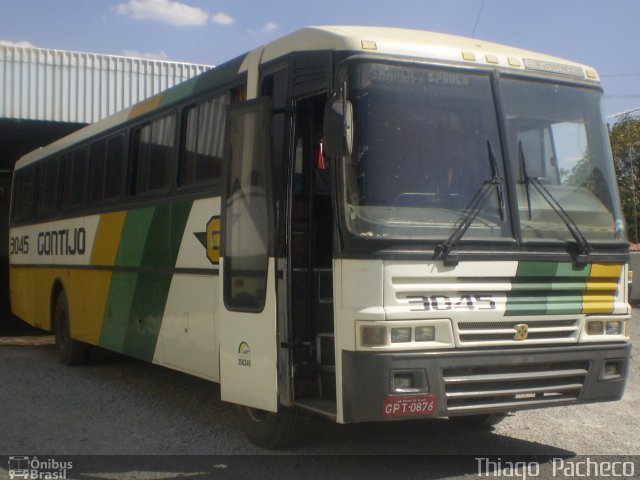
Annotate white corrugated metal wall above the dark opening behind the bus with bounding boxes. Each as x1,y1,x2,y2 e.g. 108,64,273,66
0,45,211,123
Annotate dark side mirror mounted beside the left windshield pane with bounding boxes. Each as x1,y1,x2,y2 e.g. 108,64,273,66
324,100,353,157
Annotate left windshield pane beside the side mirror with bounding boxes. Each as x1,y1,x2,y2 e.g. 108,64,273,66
344,63,512,240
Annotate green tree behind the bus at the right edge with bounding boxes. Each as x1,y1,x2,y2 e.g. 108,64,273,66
609,115,640,243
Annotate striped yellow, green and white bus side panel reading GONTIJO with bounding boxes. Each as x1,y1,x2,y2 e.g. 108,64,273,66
10,197,220,380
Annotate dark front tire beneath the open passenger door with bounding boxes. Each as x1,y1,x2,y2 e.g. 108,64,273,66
236,405,308,450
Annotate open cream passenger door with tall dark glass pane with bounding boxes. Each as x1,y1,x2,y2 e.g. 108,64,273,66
218,98,278,412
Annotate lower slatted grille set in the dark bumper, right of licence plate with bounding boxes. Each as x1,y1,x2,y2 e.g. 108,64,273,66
442,361,589,413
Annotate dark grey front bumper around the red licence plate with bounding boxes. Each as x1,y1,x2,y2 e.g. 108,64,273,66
342,343,631,423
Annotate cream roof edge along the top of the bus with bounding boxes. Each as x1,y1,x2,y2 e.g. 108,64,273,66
16,26,599,169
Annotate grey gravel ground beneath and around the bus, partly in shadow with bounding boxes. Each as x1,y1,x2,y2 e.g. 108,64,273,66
0,310,640,478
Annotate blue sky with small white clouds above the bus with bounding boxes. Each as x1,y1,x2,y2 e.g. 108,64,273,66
0,0,640,123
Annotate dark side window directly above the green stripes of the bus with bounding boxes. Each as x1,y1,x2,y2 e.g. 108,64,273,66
133,114,176,195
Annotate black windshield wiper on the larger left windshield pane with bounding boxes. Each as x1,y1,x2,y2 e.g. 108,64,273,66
433,140,504,265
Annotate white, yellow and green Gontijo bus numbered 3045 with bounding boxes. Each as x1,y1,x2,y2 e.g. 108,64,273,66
10,26,631,448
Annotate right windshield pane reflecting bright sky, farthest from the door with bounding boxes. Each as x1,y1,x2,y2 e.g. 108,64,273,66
500,78,624,244
